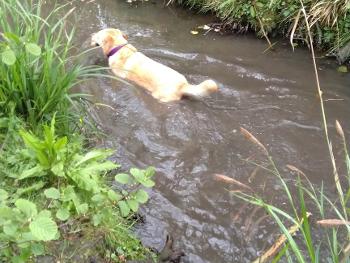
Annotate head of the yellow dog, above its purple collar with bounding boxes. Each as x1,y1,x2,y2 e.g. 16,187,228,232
91,28,128,54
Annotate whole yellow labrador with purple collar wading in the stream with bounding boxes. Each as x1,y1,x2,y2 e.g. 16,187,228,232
91,28,218,102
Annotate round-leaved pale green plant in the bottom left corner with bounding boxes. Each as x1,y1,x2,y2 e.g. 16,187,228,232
0,196,59,262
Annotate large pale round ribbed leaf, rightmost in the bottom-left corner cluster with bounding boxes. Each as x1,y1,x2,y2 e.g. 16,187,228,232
29,217,58,241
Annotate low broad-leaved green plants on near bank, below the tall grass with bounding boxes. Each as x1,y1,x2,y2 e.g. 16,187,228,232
0,118,155,256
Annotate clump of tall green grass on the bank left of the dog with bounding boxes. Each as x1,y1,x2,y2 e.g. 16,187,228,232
0,0,98,131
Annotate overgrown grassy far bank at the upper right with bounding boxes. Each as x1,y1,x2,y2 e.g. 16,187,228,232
172,0,350,61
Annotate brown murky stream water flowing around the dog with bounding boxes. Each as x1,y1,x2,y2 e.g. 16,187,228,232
63,0,350,263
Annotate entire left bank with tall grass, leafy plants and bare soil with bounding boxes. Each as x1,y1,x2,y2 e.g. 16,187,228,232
0,0,154,262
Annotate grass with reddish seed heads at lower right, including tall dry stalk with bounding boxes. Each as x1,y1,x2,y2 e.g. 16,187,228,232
235,1,350,263
